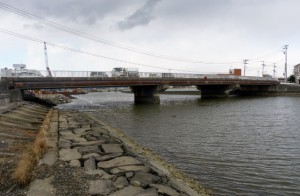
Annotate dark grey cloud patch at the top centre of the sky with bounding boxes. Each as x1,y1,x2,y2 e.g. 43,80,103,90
118,0,161,30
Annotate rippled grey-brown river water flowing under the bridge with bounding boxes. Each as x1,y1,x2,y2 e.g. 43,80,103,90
60,92,300,195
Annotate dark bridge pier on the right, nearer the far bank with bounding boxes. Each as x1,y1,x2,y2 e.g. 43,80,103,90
197,84,240,99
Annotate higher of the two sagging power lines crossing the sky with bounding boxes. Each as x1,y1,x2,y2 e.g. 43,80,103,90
0,2,239,64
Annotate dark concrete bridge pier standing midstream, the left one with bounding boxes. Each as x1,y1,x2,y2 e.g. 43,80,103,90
130,85,165,104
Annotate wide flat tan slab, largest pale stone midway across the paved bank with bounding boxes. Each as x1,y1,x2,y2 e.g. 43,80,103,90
97,156,142,169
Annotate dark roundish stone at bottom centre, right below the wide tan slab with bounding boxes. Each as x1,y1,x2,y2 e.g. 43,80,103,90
130,172,160,188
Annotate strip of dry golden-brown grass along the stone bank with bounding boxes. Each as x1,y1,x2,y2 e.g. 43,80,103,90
12,109,52,185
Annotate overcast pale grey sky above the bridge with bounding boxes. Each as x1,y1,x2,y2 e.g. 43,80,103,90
0,0,300,77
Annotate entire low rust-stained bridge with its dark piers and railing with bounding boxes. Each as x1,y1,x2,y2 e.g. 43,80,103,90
1,73,279,103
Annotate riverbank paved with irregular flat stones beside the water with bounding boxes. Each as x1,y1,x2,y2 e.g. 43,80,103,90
0,102,207,195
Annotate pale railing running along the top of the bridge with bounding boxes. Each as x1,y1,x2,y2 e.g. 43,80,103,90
1,70,277,81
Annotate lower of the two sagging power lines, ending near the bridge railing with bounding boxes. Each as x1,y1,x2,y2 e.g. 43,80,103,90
0,28,199,72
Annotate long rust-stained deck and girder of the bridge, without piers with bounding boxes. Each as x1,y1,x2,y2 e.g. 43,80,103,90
2,77,279,89
